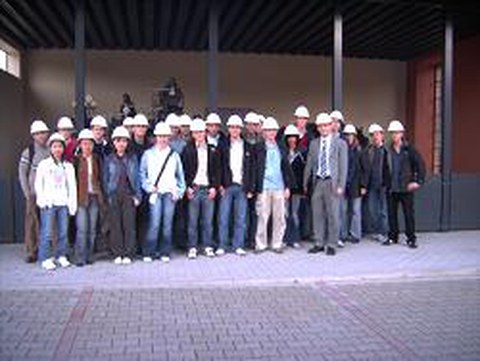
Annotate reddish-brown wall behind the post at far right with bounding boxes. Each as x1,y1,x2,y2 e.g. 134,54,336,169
407,36,480,173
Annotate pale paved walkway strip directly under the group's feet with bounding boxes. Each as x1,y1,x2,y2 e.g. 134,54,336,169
0,231,480,289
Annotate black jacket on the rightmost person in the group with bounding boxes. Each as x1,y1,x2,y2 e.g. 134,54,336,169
386,143,425,192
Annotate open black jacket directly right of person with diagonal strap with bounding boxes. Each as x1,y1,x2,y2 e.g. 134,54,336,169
181,140,222,188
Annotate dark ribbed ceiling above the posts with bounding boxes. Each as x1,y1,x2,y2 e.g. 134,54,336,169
0,0,480,60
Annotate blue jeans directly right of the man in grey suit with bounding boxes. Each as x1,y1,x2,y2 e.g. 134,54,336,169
340,197,362,240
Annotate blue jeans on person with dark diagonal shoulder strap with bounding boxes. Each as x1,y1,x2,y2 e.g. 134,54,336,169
143,193,175,257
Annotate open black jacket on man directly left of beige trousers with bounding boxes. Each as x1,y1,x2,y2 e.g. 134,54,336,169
222,139,255,193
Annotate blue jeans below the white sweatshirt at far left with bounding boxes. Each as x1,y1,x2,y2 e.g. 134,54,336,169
38,206,68,262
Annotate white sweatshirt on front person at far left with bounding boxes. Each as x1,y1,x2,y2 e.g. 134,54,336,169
35,156,77,216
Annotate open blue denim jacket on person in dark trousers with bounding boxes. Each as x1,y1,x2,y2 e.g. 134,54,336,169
103,153,142,200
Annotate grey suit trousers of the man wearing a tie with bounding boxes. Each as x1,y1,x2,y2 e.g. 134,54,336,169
312,179,341,247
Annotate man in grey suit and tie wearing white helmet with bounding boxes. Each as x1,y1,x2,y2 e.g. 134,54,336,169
303,113,348,256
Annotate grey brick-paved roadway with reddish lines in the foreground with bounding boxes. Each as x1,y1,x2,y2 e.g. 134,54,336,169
0,279,480,360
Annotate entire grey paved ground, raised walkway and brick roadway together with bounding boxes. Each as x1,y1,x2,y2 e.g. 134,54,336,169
0,231,480,361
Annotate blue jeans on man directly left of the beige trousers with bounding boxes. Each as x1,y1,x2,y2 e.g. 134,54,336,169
218,184,247,249
